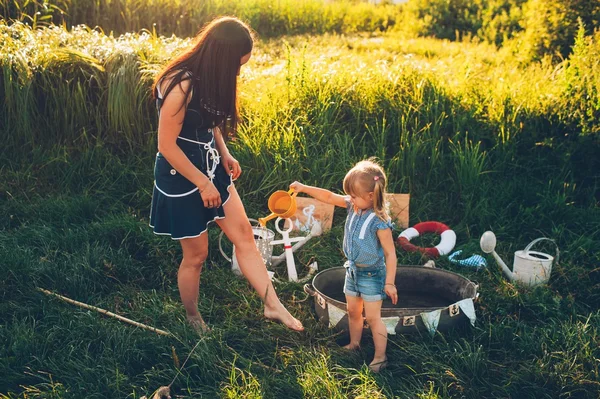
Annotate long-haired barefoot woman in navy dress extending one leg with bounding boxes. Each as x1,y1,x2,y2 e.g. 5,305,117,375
150,17,303,332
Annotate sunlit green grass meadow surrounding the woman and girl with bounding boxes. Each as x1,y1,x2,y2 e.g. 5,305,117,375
0,10,600,399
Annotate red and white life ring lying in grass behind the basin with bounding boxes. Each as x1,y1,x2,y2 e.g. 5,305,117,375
397,222,456,258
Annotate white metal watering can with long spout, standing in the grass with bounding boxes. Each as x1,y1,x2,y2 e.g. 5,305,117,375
479,231,559,286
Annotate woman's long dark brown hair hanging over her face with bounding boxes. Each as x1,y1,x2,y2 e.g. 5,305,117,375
152,17,254,138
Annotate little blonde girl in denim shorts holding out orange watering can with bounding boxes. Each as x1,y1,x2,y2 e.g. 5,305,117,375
290,160,398,372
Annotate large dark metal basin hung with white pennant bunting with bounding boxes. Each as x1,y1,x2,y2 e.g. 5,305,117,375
304,266,478,334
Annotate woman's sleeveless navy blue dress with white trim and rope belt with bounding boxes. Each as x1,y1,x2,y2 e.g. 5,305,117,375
150,73,233,240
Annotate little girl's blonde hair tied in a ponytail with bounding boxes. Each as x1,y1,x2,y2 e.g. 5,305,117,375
344,158,390,222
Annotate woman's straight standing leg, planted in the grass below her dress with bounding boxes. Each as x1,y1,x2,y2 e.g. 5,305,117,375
177,233,208,332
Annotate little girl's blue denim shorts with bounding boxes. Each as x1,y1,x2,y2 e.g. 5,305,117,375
344,262,387,302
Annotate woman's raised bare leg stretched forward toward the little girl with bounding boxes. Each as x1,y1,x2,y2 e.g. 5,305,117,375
216,186,304,331
